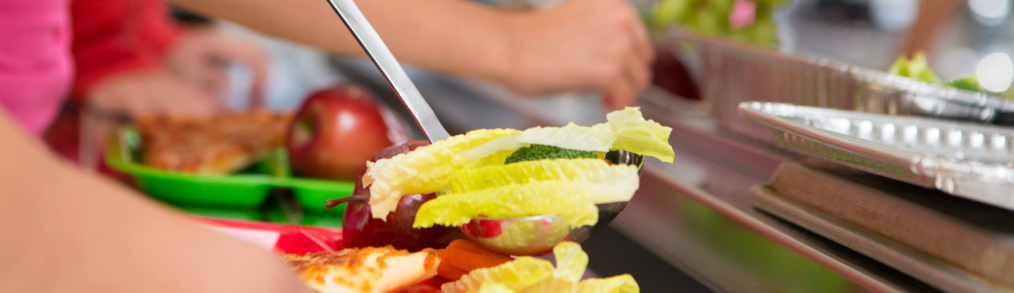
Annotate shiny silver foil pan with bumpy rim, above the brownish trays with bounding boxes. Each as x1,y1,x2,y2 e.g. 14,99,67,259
739,102,1014,210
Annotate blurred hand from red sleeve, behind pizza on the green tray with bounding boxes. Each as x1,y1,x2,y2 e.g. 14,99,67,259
85,29,268,117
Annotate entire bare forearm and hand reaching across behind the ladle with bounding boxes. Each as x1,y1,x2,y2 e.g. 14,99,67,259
168,0,654,109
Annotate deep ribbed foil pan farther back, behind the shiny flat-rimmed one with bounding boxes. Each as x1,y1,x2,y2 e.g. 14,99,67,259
654,27,1014,144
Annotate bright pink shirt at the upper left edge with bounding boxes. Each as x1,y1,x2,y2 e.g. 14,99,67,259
0,0,74,135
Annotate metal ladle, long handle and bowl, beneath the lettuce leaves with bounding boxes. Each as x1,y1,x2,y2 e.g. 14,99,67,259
328,0,644,255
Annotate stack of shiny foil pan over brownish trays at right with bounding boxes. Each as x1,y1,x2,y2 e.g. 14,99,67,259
739,101,1014,292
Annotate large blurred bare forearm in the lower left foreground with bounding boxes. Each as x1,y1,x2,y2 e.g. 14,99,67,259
0,108,308,292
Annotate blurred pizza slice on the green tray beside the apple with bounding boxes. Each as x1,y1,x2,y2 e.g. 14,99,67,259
137,111,291,173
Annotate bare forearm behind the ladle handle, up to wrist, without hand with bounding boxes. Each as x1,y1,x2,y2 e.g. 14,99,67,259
167,0,513,85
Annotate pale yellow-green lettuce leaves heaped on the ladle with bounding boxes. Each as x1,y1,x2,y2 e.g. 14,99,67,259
363,107,673,228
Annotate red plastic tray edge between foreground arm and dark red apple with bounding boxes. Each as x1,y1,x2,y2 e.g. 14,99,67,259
193,217,345,254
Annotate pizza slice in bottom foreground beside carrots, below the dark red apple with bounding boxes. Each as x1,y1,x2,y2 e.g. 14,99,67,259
285,246,440,293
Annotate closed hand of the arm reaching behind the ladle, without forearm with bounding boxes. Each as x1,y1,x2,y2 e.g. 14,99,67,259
504,0,654,109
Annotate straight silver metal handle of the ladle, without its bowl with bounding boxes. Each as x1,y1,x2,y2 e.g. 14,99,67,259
328,0,450,143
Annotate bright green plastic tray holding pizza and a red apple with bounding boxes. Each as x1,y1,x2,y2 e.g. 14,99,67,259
105,126,355,214
